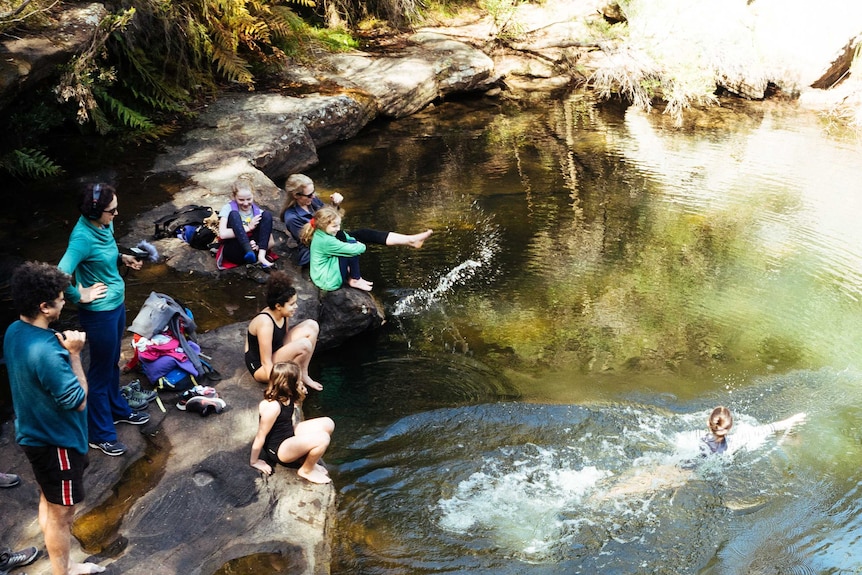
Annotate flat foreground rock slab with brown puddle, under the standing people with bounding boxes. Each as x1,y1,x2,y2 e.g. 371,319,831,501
0,323,335,575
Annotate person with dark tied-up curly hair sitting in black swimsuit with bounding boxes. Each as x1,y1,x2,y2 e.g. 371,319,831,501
245,271,323,391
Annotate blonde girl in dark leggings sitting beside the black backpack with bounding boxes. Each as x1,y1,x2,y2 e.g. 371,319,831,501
216,175,275,269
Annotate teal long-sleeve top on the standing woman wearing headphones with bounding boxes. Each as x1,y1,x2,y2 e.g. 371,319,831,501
57,216,126,311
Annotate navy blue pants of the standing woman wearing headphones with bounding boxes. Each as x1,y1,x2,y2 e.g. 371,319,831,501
78,304,132,443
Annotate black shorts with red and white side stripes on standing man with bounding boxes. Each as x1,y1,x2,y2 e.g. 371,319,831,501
21,445,90,507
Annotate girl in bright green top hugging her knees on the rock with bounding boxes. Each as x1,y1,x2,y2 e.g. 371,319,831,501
300,206,373,291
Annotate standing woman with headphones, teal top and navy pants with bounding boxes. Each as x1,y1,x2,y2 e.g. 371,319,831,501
58,184,150,455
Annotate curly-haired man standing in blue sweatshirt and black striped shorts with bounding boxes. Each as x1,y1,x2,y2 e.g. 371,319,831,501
3,262,105,575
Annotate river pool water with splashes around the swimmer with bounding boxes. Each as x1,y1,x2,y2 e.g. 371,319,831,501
298,97,862,575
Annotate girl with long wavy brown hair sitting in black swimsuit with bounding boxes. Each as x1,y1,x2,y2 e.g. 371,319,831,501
250,361,335,483
